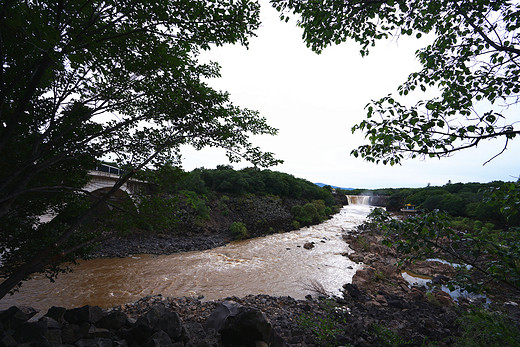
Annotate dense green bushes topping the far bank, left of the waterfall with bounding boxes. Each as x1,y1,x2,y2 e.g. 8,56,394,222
137,165,337,238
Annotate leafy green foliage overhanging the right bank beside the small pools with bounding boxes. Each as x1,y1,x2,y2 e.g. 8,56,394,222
369,209,520,292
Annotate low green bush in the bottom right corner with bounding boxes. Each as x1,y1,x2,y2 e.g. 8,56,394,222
455,309,520,347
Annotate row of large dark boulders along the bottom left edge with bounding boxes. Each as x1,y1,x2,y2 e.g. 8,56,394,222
0,300,290,347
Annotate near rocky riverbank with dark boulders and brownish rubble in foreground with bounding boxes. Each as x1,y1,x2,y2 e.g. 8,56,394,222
0,207,520,346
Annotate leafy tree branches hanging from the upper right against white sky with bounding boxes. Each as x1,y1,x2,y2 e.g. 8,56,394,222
271,0,520,165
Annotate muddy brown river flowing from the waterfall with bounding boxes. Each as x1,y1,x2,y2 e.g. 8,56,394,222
0,205,370,312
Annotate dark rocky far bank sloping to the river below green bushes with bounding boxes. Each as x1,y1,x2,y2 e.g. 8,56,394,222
89,195,346,258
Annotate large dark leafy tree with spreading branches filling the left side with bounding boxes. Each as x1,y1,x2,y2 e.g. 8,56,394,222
0,0,278,298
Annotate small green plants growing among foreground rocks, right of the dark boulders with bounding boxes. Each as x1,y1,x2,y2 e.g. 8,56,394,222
298,299,346,346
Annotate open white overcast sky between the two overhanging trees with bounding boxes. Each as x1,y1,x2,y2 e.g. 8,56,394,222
183,2,520,188
